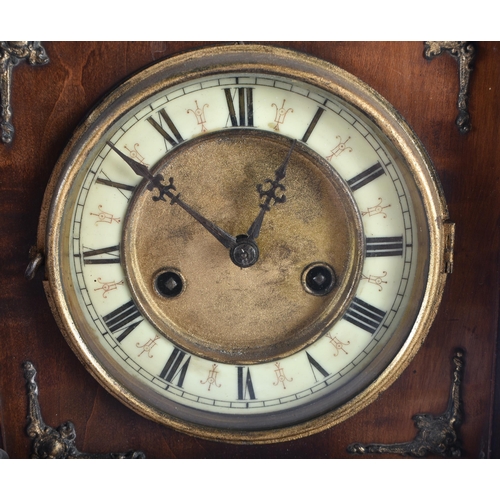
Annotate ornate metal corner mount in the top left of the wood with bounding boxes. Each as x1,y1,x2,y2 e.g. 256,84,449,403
0,42,49,144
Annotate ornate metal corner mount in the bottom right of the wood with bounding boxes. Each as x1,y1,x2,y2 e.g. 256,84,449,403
347,349,464,458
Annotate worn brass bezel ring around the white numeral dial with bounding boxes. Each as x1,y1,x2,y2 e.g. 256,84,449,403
38,45,448,444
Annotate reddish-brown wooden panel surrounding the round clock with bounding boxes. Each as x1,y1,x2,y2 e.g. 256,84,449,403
0,42,500,458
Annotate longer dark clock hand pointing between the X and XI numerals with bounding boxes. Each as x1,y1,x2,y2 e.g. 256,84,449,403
107,142,236,249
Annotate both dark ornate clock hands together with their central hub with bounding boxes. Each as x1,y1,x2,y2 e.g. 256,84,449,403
107,140,297,268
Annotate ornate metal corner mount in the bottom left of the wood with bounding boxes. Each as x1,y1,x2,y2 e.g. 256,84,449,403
24,361,146,458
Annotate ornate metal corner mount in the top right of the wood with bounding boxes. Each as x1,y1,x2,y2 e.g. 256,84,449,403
424,42,476,134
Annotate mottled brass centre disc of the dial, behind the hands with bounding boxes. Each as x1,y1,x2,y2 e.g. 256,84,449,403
121,130,364,364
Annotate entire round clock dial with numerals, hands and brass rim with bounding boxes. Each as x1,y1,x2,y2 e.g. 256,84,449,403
45,46,445,442
